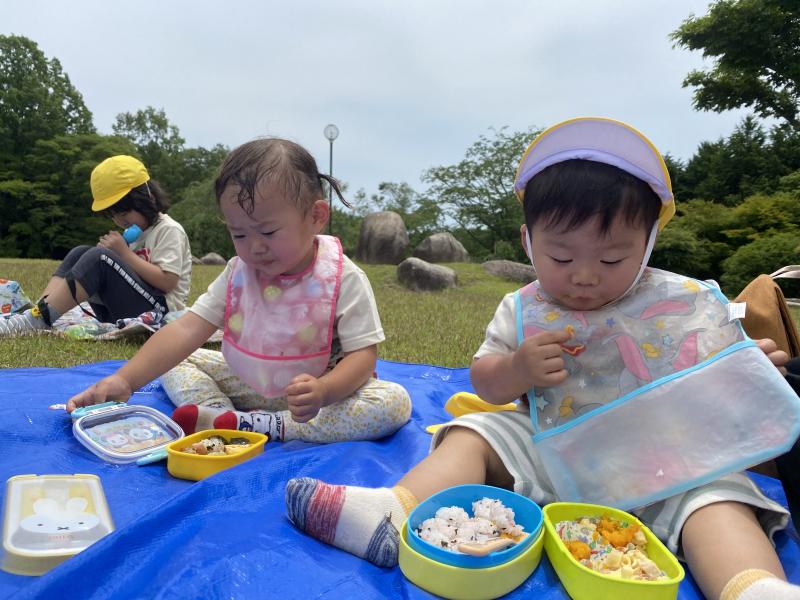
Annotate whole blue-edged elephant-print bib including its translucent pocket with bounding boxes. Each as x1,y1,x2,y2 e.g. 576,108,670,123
516,269,800,510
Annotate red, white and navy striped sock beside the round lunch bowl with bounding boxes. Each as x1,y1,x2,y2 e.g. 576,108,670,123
286,477,417,567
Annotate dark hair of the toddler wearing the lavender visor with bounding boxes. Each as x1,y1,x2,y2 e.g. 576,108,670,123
523,159,661,234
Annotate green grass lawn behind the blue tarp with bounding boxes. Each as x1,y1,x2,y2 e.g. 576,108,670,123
0,258,519,369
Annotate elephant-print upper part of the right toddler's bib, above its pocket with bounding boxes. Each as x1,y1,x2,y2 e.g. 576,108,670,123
517,269,744,431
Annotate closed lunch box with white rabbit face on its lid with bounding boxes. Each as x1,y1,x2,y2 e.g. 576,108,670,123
2,475,114,575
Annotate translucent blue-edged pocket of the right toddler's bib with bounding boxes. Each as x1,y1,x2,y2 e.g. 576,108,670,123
534,342,800,510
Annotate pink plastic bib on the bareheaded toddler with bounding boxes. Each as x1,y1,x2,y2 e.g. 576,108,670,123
222,235,344,398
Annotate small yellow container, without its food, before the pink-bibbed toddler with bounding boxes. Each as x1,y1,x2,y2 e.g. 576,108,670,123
167,429,269,481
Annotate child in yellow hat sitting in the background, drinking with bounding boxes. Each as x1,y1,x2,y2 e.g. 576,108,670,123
0,155,192,337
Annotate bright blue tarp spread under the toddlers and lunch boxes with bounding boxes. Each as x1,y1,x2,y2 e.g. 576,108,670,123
0,361,800,600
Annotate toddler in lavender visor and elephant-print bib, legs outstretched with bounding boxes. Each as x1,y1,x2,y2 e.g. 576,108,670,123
286,118,800,600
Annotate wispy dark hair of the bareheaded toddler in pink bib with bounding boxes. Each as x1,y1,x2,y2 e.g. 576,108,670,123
214,138,350,215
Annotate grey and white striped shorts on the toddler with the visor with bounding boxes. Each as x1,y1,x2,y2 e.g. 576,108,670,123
431,410,789,554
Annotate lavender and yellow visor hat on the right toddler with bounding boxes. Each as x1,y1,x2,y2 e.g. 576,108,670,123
514,117,675,230
